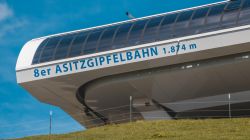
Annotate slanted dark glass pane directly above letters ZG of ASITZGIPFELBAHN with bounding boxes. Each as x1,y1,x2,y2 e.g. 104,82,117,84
82,29,103,54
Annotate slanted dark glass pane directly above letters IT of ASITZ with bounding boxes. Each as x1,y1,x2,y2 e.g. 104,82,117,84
68,32,89,57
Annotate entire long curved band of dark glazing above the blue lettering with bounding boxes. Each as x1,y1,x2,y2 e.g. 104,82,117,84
32,0,250,64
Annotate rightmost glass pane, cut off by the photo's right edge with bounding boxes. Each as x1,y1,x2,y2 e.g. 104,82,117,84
239,0,250,25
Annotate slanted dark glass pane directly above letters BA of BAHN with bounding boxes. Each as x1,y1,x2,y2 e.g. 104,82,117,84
127,20,148,46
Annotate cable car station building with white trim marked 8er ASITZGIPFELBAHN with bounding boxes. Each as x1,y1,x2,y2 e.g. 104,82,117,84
16,0,250,127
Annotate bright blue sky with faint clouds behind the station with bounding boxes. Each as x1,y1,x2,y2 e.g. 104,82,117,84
0,0,218,139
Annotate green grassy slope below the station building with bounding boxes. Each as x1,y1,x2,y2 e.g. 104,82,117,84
18,118,250,140
